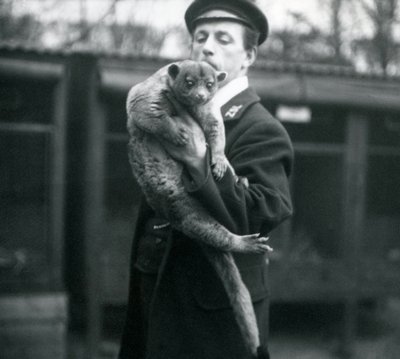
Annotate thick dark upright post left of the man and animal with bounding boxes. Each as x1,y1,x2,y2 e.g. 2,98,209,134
66,52,105,358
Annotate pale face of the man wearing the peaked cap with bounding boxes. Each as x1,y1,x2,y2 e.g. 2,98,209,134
191,21,254,85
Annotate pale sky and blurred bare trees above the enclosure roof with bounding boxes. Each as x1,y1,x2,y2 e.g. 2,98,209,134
0,0,400,75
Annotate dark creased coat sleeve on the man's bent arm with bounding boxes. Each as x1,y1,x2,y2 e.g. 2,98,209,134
187,110,293,235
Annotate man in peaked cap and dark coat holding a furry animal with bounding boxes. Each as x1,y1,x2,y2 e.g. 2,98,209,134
119,0,293,359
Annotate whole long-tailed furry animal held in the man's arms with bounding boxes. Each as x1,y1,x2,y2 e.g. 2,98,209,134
127,60,267,357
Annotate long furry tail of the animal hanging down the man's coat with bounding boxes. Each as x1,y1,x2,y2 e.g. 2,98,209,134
204,246,265,358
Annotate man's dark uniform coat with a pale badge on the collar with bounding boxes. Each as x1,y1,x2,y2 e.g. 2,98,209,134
119,89,293,359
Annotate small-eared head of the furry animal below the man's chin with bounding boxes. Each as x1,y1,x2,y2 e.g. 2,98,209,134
168,60,227,106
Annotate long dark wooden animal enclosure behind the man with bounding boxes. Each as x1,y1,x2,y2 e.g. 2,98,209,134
0,48,400,358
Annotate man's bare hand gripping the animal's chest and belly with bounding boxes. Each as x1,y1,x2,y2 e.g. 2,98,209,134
161,93,207,183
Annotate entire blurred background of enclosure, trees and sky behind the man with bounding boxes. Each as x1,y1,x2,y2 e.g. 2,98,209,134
0,0,400,359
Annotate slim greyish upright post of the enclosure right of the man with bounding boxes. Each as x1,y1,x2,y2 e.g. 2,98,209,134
340,113,368,358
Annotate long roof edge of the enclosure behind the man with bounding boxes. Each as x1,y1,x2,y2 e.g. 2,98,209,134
0,41,400,112
